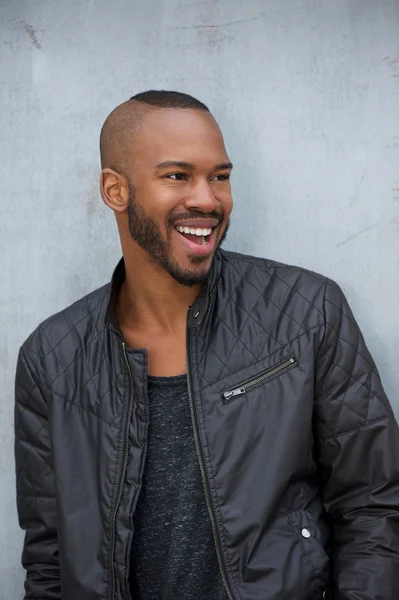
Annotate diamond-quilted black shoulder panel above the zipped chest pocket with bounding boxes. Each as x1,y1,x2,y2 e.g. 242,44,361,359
198,255,325,386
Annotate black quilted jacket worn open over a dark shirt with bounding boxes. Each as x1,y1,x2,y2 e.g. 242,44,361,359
15,251,399,600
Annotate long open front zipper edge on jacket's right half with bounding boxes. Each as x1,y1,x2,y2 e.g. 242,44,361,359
186,318,234,600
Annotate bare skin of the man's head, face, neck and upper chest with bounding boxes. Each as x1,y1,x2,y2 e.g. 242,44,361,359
101,102,232,376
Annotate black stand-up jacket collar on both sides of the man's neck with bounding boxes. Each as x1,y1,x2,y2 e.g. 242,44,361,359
104,248,223,335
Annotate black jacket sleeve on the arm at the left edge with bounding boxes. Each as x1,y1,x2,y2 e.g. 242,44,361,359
15,349,61,600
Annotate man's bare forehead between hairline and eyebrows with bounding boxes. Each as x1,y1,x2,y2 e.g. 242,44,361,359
133,108,228,168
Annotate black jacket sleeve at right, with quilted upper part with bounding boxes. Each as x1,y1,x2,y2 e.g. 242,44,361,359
315,281,399,600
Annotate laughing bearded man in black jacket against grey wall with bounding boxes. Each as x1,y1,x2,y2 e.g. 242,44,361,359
16,91,399,600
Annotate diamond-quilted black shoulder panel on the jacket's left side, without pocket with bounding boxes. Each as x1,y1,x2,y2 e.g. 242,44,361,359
22,286,124,424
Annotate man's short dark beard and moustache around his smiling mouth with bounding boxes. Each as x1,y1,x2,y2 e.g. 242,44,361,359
128,182,230,287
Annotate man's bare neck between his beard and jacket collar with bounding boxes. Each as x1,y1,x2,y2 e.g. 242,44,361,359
117,250,202,333
